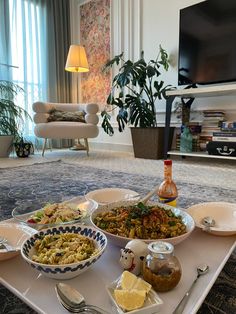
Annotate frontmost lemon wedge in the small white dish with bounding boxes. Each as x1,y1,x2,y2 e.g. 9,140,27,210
114,289,146,311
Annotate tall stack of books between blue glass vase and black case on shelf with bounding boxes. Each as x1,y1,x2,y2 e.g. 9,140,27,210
199,110,225,151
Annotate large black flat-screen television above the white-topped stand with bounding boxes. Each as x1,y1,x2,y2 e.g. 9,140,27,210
178,0,236,85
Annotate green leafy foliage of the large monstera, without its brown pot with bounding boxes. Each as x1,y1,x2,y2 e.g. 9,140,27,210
101,46,170,135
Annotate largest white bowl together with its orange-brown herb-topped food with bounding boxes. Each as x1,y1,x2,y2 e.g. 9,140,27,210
90,201,195,247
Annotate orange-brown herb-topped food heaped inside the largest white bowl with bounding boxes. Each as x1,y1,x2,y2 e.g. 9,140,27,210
94,203,187,239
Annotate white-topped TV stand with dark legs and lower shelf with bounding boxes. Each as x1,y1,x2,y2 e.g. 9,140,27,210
164,84,236,160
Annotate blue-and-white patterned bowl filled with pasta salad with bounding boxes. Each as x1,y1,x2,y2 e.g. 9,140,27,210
21,224,107,280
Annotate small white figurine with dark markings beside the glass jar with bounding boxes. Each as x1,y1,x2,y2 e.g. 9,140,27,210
120,239,148,275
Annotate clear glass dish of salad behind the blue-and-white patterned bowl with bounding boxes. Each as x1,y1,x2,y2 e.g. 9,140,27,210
12,197,98,230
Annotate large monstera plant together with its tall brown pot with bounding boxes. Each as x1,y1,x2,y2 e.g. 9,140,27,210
101,45,173,159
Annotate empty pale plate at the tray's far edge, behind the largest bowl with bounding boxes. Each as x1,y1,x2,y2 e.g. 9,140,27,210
85,188,140,205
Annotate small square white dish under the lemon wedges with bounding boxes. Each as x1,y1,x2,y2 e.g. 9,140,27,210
106,277,163,314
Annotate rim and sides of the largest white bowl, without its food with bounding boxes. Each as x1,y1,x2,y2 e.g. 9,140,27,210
90,201,195,247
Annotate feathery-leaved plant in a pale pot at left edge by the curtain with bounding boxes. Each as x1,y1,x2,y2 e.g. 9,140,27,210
0,80,29,157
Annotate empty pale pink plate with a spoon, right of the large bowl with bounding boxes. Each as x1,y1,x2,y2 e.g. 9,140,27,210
187,202,236,236
